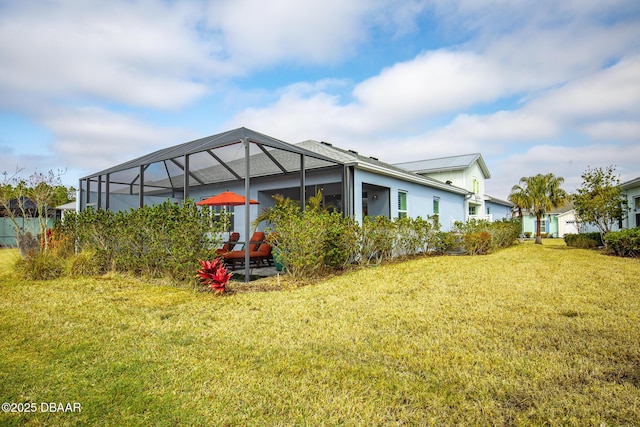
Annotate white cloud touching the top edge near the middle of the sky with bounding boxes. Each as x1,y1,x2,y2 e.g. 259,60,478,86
208,0,375,68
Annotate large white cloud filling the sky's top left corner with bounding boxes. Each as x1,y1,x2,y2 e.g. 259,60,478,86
0,1,218,108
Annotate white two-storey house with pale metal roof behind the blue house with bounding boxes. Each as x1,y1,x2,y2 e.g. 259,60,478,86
396,153,513,221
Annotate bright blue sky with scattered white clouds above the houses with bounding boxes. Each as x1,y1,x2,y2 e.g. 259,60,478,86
0,0,640,199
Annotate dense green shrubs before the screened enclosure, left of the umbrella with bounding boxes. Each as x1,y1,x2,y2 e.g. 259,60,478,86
58,200,226,281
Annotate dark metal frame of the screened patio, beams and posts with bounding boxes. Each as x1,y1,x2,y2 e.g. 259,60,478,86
79,127,344,281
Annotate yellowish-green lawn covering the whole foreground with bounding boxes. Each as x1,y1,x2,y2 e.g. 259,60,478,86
0,240,640,426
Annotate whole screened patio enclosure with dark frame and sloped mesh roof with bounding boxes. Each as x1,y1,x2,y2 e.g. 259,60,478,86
79,128,352,280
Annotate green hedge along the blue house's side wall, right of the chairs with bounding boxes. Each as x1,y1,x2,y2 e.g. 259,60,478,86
264,199,520,277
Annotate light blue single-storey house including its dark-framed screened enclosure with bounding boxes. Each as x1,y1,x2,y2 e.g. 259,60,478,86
78,128,471,234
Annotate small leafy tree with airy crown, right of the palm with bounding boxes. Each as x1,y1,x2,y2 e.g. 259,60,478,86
572,166,628,246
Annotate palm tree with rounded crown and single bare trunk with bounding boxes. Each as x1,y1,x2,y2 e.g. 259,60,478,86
509,173,569,244
